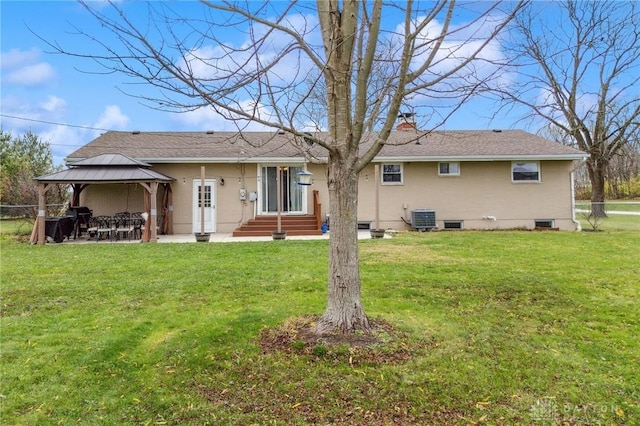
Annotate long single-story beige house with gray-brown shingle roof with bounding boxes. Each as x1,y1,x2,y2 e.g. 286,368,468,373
33,127,586,243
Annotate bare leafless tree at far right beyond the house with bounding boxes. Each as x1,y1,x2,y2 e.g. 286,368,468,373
498,0,640,215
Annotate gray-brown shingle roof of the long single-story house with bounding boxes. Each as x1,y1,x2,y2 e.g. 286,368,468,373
68,130,586,163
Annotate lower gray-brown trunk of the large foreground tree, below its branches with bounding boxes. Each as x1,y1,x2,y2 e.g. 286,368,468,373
315,156,369,334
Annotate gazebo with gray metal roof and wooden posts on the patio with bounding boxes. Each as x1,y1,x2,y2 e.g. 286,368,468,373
31,154,175,244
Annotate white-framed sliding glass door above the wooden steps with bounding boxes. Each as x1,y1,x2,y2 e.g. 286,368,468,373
260,166,306,214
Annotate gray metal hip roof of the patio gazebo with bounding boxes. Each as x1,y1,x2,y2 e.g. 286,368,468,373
35,154,175,183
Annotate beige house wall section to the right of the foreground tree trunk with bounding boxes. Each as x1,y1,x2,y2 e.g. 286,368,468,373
358,161,575,230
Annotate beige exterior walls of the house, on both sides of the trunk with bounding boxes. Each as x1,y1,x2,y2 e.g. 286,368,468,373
81,161,575,234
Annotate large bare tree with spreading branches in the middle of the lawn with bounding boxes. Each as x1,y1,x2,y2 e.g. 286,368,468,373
47,0,521,333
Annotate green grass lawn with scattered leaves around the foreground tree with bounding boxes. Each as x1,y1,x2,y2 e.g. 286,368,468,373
0,231,640,425
